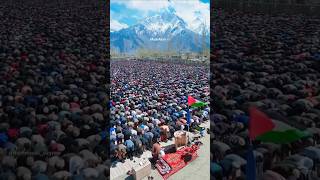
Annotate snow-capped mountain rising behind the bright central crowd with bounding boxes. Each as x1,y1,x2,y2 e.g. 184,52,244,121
110,8,209,53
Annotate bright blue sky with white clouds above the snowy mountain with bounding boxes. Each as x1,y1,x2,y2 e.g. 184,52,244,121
110,0,210,31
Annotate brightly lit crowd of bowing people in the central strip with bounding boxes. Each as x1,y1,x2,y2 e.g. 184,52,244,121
109,60,210,162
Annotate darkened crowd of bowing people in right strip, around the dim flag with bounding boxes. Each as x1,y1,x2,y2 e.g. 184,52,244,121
210,10,320,180
